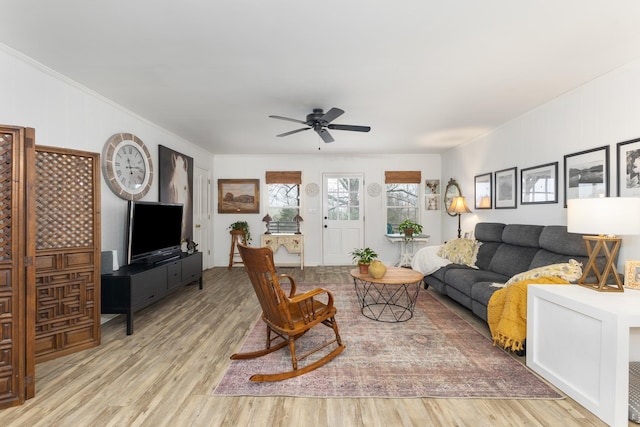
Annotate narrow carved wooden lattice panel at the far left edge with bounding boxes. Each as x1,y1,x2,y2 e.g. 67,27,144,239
0,125,35,408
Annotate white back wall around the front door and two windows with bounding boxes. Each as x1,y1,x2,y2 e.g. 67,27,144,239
213,154,442,266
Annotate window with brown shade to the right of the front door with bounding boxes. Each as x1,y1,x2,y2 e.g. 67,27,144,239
385,171,422,233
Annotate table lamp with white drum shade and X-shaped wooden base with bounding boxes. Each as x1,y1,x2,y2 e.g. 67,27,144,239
567,197,640,292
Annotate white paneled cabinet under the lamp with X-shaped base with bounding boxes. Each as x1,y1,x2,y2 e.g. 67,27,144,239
527,285,640,426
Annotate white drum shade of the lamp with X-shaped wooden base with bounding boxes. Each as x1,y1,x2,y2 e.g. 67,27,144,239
567,197,640,236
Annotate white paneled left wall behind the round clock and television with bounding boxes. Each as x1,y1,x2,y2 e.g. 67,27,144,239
0,44,213,265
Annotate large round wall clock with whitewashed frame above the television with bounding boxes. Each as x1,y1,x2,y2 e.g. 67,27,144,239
102,133,153,200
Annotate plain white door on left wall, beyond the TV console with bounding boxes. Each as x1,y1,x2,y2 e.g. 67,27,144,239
193,166,212,270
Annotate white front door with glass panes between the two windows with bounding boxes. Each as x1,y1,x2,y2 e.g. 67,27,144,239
322,173,364,265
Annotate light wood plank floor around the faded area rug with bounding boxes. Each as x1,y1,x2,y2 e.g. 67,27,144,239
0,267,605,427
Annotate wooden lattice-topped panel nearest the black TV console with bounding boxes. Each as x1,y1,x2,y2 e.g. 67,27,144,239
35,146,100,362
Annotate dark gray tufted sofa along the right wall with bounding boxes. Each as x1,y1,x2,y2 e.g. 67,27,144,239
424,222,604,321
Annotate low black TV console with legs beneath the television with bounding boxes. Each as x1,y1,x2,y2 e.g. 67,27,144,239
100,252,202,335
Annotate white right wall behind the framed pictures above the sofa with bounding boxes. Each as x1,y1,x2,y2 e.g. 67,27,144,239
442,60,640,272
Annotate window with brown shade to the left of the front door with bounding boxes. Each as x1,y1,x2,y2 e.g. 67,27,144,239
265,171,302,233
